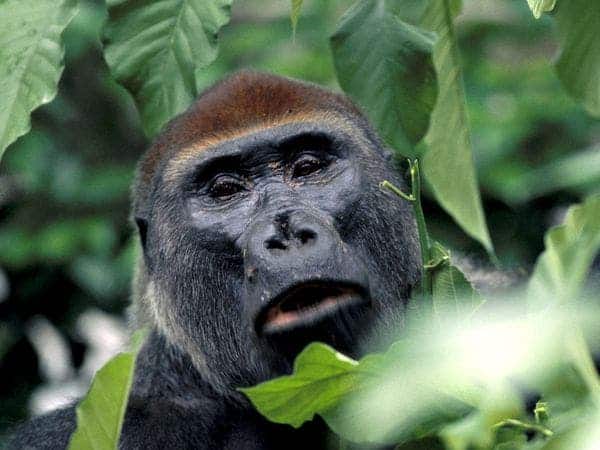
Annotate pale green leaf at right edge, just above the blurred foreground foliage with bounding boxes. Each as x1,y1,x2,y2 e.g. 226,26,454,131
528,195,600,306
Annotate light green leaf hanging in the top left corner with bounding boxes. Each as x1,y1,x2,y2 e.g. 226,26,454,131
0,0,77,157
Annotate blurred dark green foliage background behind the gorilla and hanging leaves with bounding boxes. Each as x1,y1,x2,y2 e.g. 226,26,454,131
0,0,600,440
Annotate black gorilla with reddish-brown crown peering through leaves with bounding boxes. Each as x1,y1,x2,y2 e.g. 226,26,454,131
9,71,421,450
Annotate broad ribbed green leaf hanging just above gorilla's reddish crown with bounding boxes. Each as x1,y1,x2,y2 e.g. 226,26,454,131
105,0,233,136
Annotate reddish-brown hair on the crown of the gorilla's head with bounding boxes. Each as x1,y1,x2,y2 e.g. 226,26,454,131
136,70,360,214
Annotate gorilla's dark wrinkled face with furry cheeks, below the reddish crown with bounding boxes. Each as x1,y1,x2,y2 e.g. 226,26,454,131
145,118,420,392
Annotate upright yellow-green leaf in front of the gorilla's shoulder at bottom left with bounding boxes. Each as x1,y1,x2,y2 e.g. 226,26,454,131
69,331,144,450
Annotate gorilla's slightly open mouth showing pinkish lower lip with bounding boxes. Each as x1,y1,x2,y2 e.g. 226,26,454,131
256,282,368,335
